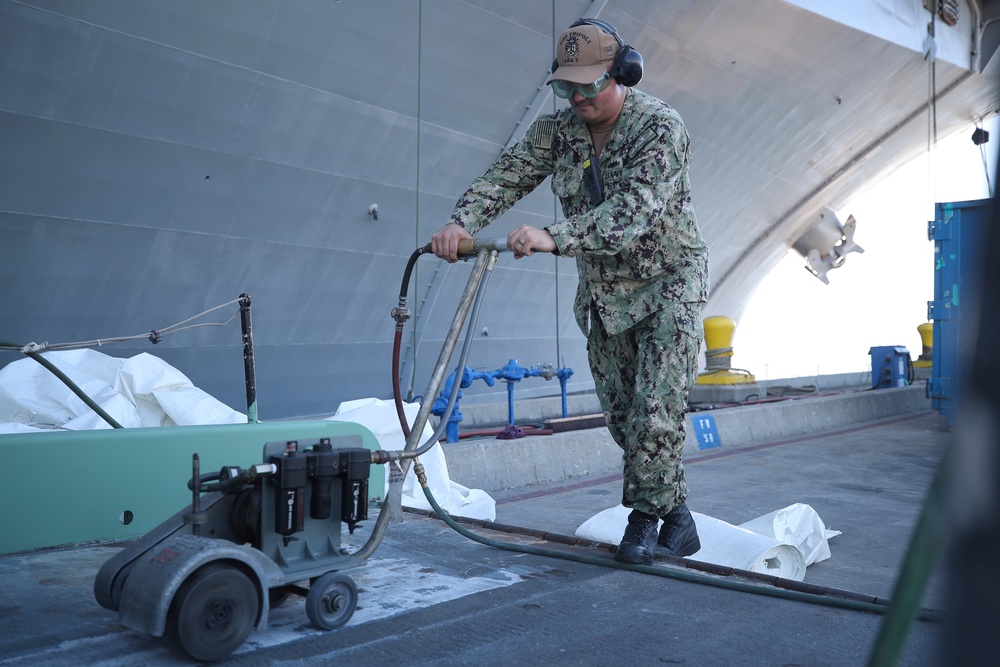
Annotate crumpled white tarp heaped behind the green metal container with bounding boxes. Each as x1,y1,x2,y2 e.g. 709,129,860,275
0,349,247,433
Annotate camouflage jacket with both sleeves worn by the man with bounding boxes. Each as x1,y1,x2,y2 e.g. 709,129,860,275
450,89,708,335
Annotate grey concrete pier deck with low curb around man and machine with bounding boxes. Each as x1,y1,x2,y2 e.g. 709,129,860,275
0,387,951,666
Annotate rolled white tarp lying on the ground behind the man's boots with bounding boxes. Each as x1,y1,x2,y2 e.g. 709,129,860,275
576,503,840,581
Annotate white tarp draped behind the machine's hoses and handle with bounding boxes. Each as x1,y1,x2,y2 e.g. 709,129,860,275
328,398,496,521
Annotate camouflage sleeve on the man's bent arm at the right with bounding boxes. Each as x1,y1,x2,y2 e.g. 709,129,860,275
546,115,691,256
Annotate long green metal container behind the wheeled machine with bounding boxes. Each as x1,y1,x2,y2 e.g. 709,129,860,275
0,420,385,554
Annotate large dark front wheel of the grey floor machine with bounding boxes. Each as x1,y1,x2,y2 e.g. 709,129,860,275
163,563,260,661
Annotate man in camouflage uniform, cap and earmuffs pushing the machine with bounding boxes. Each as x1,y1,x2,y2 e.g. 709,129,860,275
431,19,708,564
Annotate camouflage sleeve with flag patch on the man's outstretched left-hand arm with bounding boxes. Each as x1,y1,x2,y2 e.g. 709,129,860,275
448,116,554,234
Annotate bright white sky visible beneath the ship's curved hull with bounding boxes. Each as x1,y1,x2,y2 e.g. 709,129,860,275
732,117,1000,380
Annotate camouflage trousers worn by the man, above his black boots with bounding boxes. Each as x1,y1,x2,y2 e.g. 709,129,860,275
587,303,703,516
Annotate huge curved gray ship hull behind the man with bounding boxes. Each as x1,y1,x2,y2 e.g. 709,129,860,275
0,0,998,420
